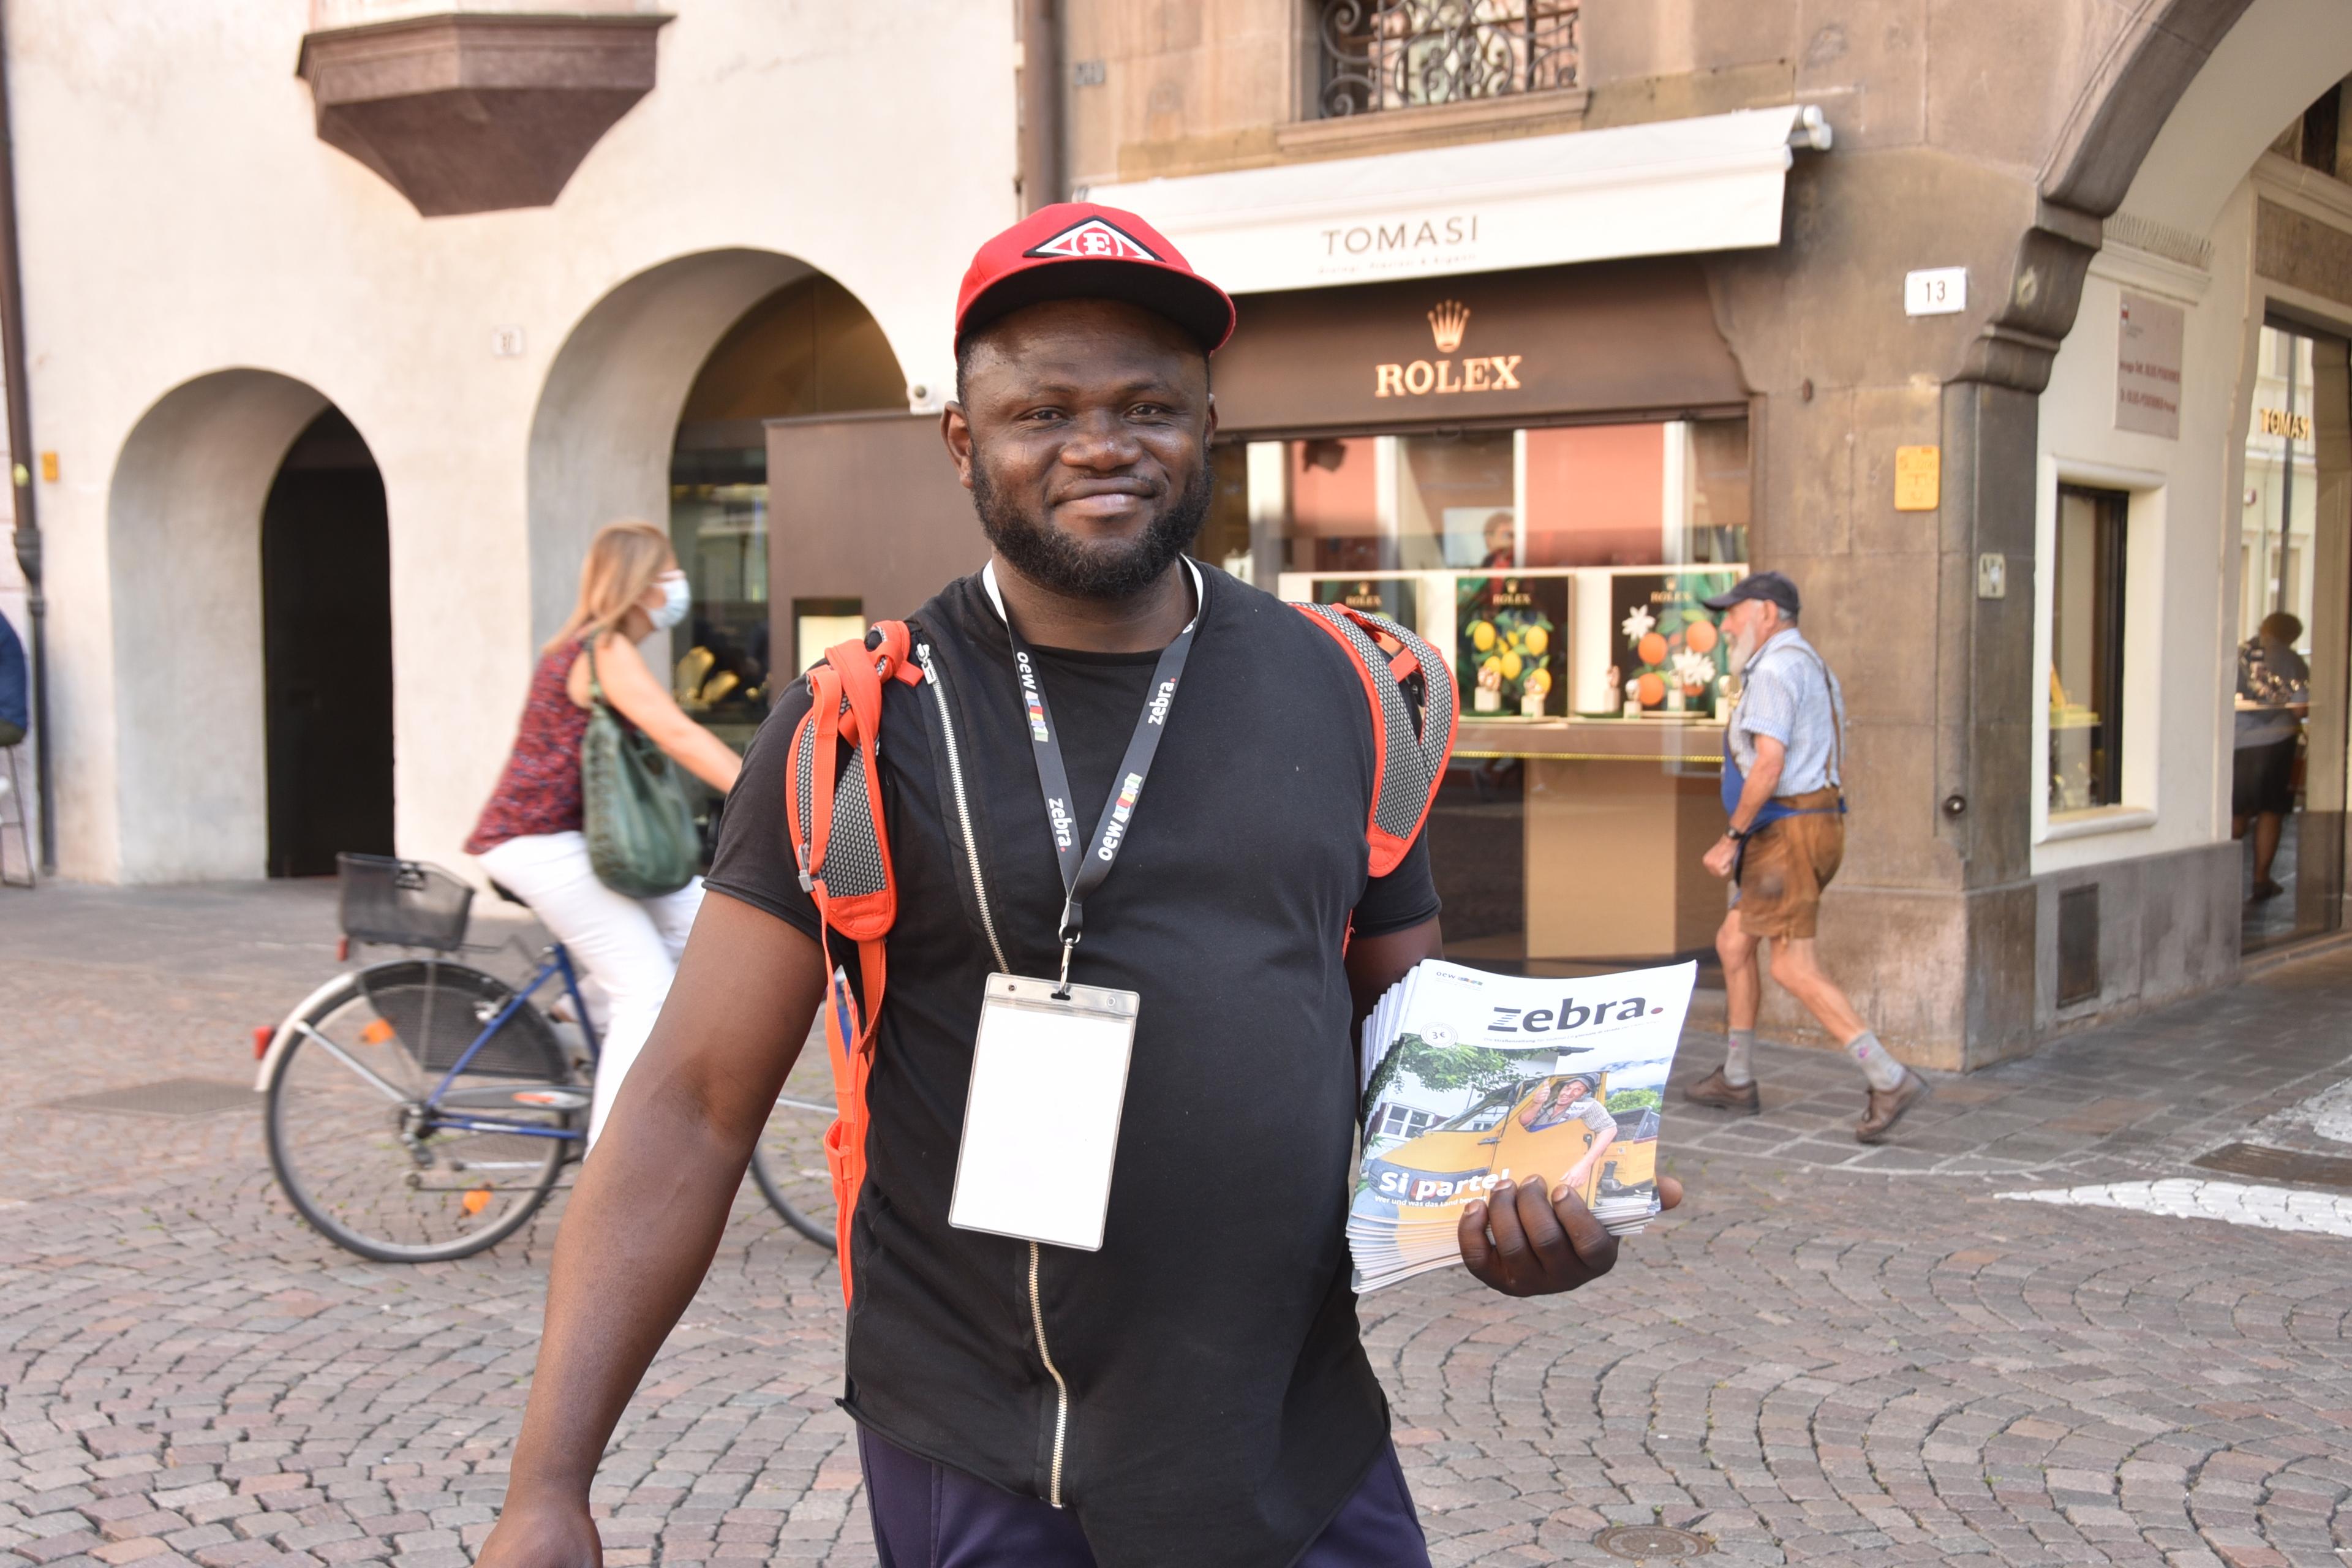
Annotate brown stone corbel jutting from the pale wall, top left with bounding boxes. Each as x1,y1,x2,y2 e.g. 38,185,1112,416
294,12,670,219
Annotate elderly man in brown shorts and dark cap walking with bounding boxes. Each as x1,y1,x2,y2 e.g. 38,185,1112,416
1684,571,1929,1142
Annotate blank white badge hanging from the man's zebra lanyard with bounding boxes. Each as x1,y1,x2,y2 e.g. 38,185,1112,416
948,976,1140,1253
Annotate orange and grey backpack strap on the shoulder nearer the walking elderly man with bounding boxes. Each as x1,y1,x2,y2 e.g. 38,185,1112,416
1298,604,1456,877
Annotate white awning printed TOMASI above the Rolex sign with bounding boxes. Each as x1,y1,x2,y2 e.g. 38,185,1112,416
1087,106,1830,294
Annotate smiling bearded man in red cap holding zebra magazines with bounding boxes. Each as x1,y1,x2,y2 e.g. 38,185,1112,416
480,202,1679,1568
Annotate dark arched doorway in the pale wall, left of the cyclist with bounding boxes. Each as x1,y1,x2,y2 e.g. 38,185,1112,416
261,409,393,877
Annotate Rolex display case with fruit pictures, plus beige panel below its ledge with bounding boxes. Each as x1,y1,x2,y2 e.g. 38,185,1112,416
1277,564,1747,973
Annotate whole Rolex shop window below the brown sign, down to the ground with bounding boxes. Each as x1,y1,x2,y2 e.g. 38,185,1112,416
1270,416,1750,973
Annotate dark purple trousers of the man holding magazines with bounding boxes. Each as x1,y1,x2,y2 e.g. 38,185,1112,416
859,1427,1430,1568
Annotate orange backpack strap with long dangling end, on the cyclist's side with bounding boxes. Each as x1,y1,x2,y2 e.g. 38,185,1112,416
783,620,922,1305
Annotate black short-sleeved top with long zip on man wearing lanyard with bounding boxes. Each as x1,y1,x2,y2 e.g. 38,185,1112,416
708,571,1437,1568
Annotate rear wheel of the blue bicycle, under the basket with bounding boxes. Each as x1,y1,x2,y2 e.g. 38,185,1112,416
263,959,588,1262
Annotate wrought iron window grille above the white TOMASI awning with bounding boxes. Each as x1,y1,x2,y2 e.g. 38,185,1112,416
1317,0,1578,118
